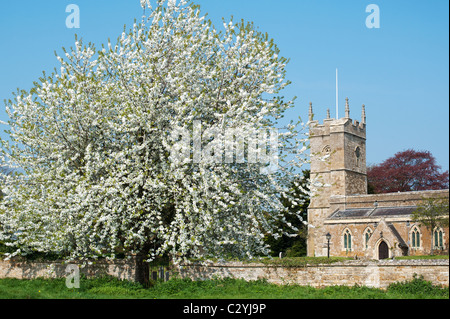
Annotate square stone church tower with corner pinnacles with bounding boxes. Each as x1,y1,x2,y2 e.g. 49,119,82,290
308,98,367,256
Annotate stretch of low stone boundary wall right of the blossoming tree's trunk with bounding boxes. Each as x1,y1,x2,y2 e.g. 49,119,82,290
177,259,449,288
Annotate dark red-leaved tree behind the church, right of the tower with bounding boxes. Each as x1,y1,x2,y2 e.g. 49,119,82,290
367,149,449,194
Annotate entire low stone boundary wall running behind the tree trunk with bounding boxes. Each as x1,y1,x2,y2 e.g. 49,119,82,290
0,259,449,288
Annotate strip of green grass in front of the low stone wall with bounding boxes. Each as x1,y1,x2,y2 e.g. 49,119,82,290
0,277,449,299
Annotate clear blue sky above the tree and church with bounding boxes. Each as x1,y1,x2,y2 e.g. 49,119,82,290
0,0,449,170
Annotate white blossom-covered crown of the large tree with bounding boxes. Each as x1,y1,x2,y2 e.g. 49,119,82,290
0,0,306,261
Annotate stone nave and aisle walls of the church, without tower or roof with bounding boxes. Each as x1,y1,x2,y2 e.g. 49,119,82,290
324,189,449,259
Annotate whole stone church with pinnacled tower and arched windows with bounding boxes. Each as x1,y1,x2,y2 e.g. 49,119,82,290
307,98,449,259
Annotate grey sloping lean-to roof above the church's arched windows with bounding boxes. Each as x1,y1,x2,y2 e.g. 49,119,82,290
328,206,417,220
